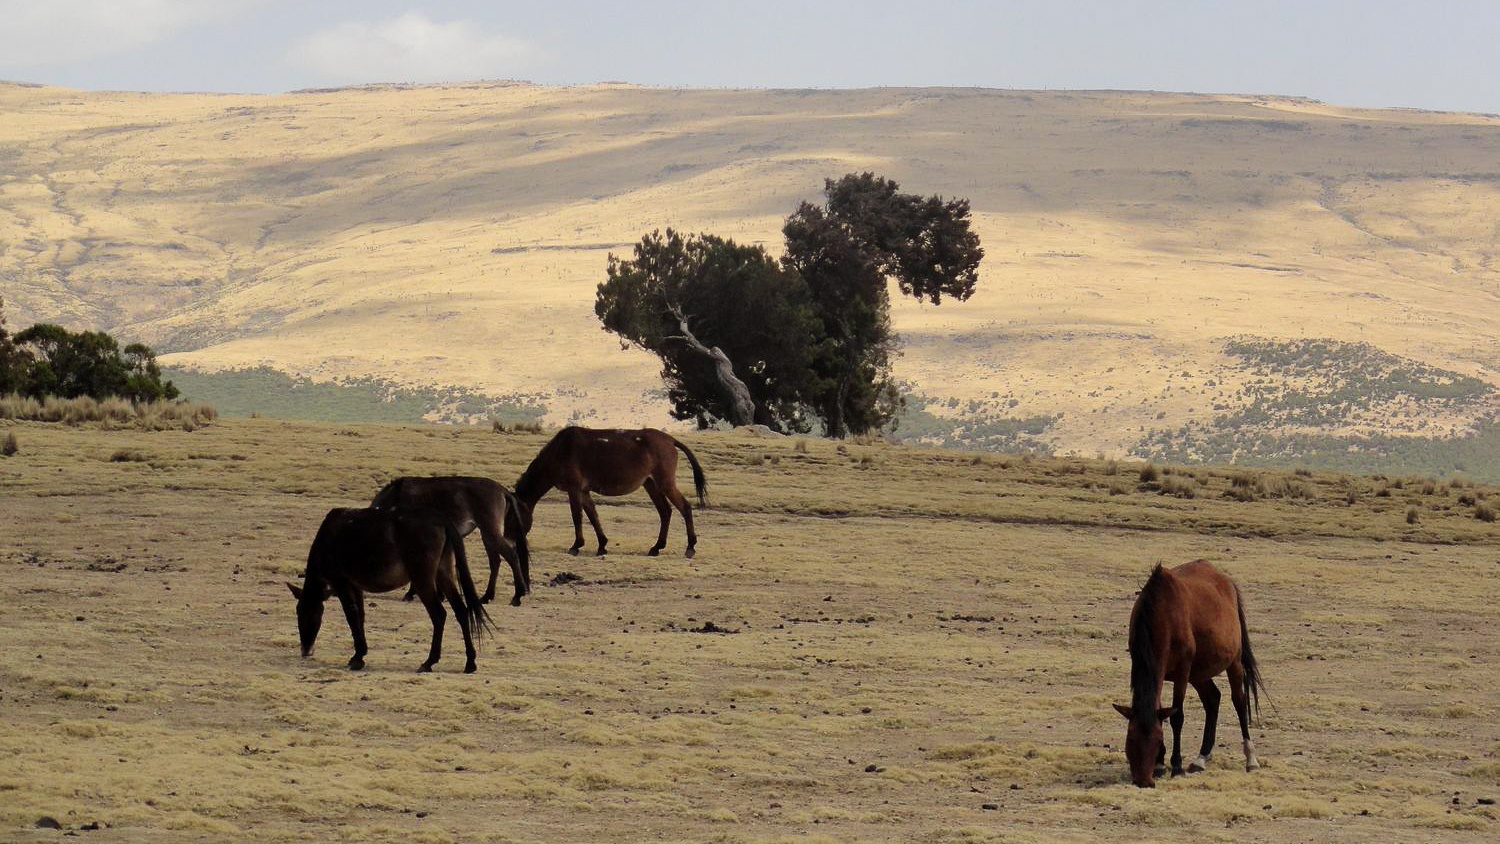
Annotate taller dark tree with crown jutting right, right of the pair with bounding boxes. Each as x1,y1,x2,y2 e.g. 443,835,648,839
782,172,984,436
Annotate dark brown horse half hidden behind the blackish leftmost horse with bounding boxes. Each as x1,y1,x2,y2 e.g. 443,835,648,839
371,477,531,607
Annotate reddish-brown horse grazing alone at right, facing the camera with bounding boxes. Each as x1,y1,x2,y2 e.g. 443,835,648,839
1115,559,1265,789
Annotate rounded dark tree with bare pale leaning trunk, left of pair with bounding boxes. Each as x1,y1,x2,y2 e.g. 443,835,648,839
594,229,819,430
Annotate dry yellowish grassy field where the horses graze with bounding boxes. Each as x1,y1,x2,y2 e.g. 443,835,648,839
0,420,1500,844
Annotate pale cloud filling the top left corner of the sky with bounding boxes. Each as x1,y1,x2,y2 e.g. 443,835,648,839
0,0,251,69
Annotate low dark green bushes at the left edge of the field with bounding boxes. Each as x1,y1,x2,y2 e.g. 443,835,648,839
0,298,179,402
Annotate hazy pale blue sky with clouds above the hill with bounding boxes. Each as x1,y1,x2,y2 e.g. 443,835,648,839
0,0,1500,112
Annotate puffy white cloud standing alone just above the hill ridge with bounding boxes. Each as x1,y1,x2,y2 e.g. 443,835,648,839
290,12,542,82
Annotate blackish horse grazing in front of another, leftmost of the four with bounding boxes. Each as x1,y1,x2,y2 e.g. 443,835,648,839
287,507,492,675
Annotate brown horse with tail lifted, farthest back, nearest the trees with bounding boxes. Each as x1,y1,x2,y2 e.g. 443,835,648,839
516,427,708,556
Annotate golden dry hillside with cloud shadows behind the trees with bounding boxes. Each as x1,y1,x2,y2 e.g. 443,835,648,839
0,84,1500,477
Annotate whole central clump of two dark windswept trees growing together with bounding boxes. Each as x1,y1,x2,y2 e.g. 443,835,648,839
594,172,984,436
